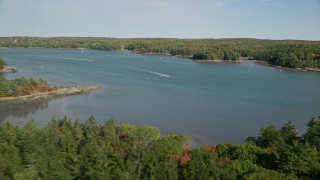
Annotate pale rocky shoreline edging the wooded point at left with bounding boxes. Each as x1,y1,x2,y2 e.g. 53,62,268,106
0,85,99,103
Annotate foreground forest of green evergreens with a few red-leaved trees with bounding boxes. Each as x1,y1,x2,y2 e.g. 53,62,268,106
0,117,320,179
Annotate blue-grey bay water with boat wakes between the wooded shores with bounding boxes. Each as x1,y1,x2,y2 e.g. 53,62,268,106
0,48,320,145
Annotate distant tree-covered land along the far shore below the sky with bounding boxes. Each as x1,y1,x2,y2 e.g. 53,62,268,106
0,37,320,69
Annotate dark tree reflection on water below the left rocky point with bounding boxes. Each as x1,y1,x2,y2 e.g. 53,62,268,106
0,100,49,123
